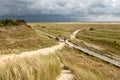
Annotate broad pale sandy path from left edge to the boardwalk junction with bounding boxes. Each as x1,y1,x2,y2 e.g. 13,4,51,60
0,43,65,63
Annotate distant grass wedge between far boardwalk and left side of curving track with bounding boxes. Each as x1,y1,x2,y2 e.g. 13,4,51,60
28,23,81,38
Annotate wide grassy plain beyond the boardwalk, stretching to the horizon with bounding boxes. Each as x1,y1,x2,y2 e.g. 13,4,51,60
29,23,120,58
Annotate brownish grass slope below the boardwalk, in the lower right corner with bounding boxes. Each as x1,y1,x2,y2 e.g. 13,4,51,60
57,47,120,80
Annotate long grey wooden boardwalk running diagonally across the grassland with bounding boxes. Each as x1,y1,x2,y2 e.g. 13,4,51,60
40,30,120,68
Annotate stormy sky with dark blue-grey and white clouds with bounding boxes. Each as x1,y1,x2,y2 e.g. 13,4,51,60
0,0,120,22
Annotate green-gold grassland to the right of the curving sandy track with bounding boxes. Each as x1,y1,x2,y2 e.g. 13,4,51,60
76,24,120,56
